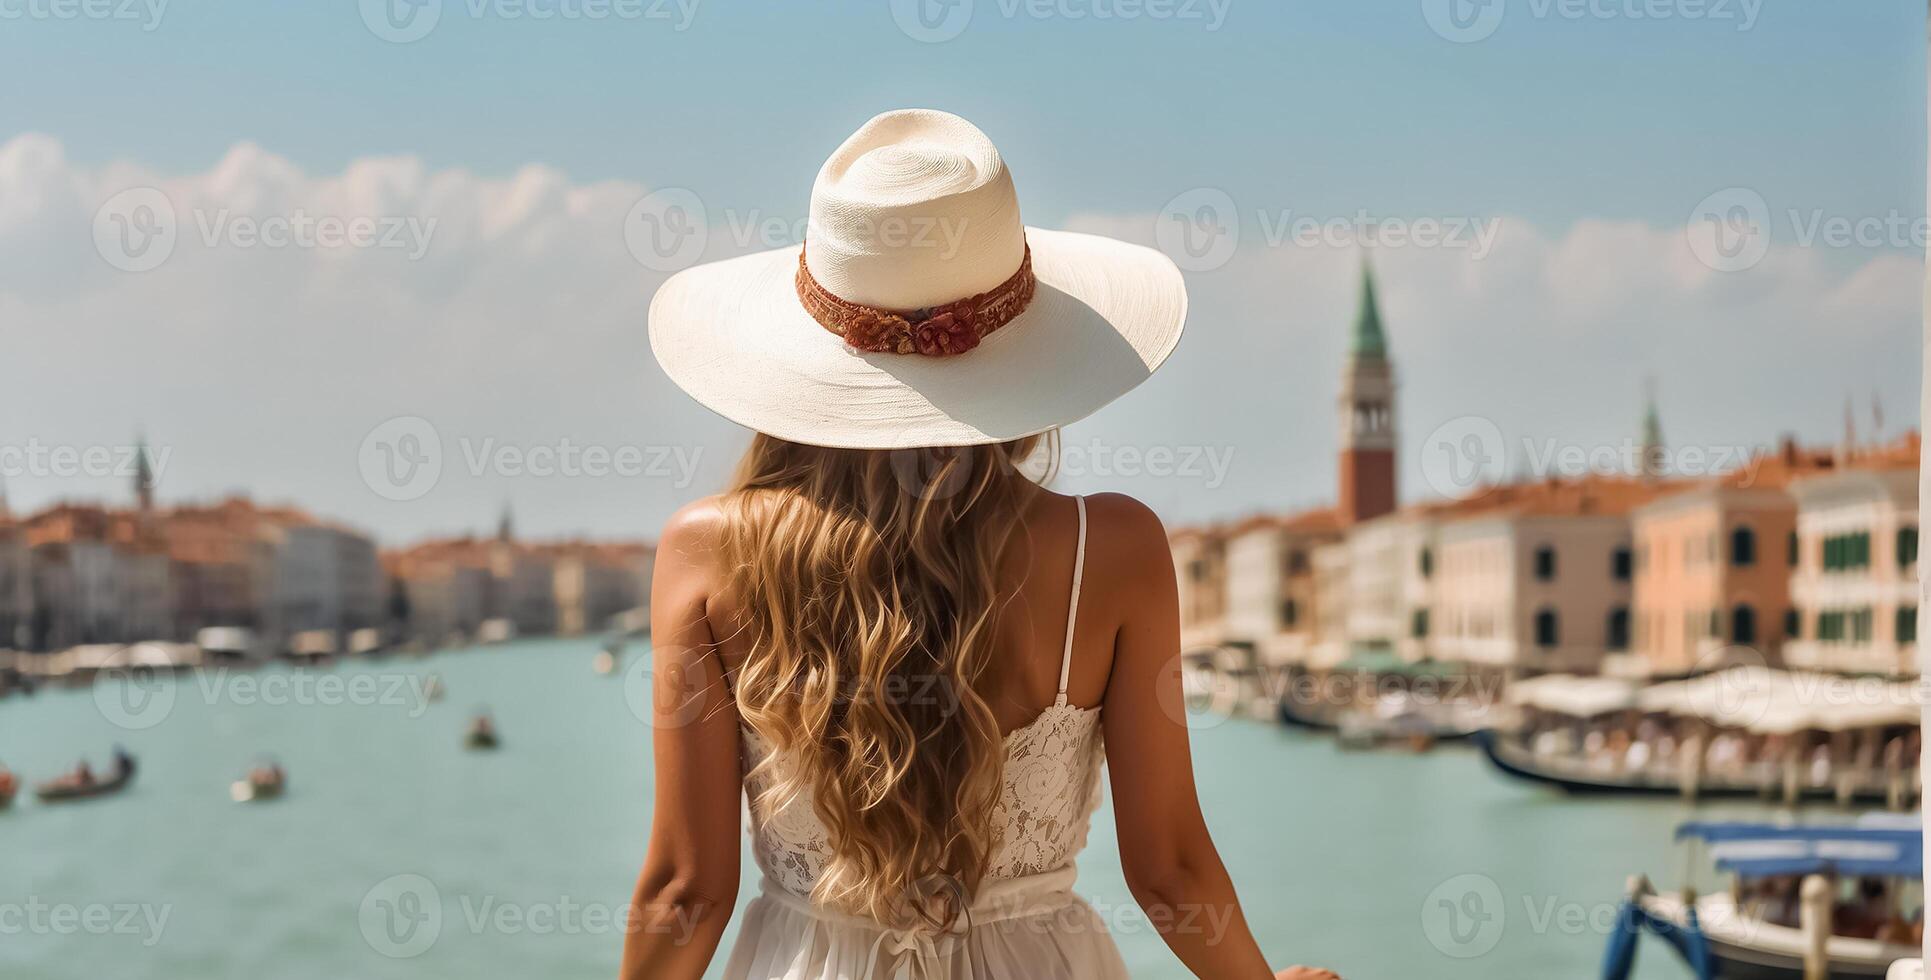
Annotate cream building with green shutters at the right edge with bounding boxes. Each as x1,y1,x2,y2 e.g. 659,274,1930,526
1782,436,1917,675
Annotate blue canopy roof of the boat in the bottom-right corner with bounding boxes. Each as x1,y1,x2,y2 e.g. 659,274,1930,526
1676,822,1925,878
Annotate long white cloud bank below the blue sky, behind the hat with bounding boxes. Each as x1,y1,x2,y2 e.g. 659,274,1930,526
0,135,1921,536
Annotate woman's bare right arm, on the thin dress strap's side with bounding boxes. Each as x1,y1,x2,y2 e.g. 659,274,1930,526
1095,494,1332,980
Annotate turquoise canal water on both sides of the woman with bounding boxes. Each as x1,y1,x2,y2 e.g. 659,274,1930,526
0,640,1799,980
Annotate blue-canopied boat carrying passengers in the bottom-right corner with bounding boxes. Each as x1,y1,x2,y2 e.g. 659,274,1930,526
1603,820,1923,980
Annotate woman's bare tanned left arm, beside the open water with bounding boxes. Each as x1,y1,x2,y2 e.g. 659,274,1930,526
622,502,742,980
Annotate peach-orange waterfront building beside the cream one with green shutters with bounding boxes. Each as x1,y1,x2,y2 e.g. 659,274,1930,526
1632,438,1836,675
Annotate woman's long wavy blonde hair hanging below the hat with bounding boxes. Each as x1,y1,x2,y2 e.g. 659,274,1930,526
724,434,1050,924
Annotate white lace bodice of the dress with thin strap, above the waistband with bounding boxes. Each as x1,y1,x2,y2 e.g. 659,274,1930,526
743,498,1105,895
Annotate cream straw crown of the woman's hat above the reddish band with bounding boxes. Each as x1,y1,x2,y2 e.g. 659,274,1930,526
805,108,1025,311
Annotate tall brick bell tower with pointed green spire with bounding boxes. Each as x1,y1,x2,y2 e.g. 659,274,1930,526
1340,255,1394,525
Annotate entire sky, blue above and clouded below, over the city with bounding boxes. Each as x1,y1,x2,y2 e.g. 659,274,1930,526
0,0,1925,538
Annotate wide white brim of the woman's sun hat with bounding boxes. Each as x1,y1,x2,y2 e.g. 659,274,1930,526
651,228,1188,449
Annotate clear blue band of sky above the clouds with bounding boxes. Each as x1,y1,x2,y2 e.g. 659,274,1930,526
0,0,1925,228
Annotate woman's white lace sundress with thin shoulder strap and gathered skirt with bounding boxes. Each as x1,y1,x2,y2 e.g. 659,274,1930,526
724,500,1126,980
